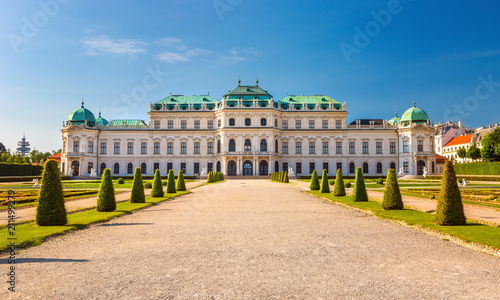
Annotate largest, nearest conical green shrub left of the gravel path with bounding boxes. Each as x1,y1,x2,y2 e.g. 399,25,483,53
35,159,68,226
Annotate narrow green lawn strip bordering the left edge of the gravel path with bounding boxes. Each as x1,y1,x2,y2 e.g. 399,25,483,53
0,192,190,251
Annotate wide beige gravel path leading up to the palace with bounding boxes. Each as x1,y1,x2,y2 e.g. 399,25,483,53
0,180,500,299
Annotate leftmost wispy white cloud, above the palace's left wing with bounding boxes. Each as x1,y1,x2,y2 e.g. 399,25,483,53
83,36,147,55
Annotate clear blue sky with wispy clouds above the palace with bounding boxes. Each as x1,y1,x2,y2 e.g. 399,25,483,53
0,0,500,151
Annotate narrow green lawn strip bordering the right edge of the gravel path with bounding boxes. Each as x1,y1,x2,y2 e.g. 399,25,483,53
308,191,500,249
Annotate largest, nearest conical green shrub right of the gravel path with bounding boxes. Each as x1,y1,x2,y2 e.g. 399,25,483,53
436,160,465,225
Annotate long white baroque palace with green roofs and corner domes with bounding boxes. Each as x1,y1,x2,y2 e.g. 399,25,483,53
61,81,436,176
